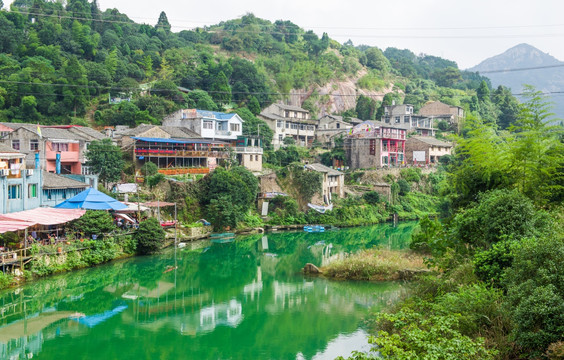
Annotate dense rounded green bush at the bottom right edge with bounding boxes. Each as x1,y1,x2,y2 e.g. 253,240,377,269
505,234,564,357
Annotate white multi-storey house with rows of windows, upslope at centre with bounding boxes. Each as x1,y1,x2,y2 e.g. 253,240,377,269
259,104,318,148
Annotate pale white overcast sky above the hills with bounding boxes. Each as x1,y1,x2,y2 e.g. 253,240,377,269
4,0,564,69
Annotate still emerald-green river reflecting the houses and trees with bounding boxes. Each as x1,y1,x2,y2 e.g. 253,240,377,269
0,223,415,360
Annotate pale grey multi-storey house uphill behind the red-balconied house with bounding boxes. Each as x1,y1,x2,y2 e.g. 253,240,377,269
382,104,435,136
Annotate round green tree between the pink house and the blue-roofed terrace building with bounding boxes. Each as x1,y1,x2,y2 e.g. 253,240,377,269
84,139,125,188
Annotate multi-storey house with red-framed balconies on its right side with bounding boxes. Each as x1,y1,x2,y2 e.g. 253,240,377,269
344,121,407,169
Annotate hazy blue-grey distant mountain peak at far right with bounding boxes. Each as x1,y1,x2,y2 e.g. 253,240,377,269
468,44,564,118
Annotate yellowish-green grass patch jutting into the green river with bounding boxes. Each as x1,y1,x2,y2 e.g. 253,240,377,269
323,249,427,281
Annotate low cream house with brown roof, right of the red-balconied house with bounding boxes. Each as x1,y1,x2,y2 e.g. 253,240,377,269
405,136,452,165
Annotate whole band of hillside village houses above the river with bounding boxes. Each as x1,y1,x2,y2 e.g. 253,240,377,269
0,98,454,213
